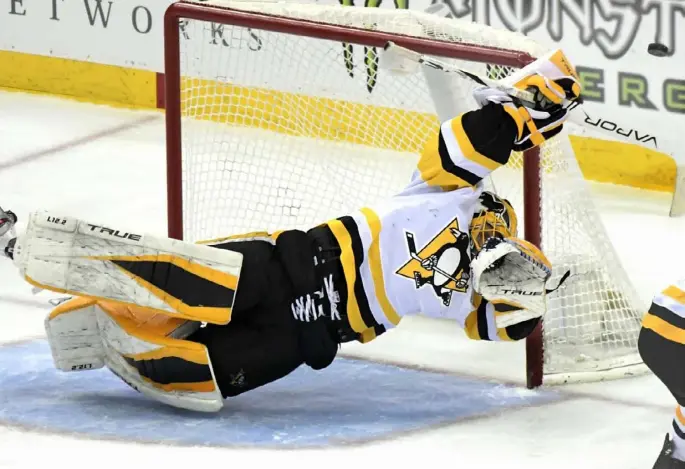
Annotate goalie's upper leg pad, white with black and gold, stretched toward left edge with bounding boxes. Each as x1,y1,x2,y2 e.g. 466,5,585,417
8,212,242,324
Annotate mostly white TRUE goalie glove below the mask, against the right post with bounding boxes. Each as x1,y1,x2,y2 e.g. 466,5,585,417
471,238,569,328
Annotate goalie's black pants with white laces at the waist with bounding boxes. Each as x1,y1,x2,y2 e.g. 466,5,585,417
187,228,358,397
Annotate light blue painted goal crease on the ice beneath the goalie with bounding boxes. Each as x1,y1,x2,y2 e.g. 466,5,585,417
0,341,560,447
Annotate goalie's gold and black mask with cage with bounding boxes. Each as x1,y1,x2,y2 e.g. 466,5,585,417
470,191,518,256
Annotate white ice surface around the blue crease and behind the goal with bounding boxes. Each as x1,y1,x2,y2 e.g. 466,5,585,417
0,92,685,469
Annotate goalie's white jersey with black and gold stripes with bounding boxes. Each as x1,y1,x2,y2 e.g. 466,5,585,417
326,106,524,342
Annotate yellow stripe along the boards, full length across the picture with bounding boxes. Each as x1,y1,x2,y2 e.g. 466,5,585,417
0,51,676,192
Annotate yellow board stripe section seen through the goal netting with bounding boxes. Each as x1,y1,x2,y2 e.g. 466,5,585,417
181,77,439,153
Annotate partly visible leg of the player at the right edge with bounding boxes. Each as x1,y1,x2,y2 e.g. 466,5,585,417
638,286,685,469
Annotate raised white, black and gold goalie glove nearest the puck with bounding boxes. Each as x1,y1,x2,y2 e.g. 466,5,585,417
473,50,582,151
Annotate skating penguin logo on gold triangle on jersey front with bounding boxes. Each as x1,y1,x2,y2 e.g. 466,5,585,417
396,219,471,306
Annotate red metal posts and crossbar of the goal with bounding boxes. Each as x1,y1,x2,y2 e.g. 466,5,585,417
164,1,544,389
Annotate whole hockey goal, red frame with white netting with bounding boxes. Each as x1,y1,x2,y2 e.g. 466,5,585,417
165,0,644,387
